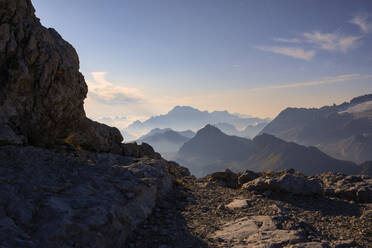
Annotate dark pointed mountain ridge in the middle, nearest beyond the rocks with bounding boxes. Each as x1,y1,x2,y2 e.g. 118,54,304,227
176,125,360,176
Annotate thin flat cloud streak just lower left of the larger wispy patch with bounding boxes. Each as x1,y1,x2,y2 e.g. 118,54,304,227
256,46,315,61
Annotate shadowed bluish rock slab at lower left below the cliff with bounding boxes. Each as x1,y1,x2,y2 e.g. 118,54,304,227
0,146,178,247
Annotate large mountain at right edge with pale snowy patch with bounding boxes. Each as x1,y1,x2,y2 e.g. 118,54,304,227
261,94,372,163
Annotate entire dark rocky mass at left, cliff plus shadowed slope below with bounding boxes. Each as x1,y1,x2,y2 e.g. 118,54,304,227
0,0,188,247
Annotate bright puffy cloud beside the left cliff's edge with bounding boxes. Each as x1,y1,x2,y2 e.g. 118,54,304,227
87,72,143,105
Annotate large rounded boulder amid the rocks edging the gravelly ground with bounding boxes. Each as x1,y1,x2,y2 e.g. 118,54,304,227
242,172,322,195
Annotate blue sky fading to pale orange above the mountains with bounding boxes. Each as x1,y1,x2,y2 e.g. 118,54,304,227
32,0,372,128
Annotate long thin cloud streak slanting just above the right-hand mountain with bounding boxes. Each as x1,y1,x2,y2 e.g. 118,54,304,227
249,74,372,91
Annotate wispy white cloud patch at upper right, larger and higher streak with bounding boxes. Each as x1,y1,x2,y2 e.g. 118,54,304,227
303,31,362,52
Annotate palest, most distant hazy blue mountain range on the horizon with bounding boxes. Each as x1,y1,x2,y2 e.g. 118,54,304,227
125,106,269,137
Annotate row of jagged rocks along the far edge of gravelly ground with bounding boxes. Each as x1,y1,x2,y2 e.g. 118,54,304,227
205,169,372,203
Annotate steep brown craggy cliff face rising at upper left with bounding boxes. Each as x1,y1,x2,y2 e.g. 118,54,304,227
0,0,123,153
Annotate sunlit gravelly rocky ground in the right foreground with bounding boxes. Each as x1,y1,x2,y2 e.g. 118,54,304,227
126,170,372,248
